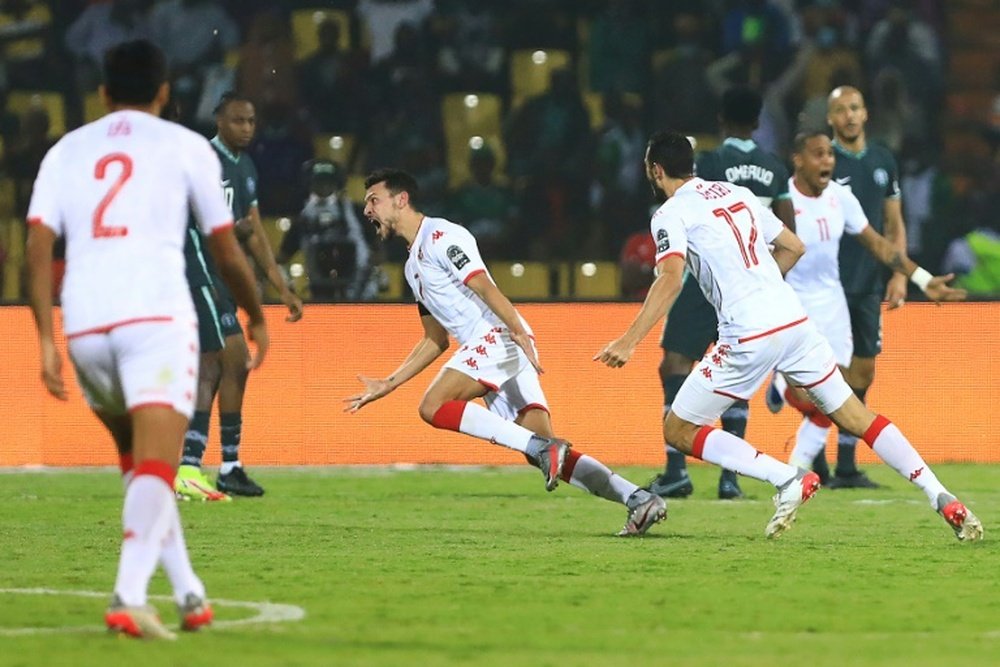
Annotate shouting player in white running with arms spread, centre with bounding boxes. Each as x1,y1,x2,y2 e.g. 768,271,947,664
344,169,666,536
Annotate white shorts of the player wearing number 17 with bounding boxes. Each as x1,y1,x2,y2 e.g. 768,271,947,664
671,319,853,424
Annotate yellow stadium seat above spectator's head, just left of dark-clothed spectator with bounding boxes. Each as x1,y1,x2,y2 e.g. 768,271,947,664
441,93,504,188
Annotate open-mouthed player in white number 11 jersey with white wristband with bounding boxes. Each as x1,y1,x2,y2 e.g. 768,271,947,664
775,131,964,480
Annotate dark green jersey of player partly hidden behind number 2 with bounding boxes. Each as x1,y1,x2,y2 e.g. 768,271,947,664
184,136,257,289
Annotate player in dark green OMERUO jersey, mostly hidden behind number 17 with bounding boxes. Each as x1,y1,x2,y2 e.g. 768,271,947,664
649,87,795,500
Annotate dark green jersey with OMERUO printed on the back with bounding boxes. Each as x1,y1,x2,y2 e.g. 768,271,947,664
695,137,789,207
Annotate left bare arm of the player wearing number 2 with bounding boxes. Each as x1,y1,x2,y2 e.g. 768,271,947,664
25,224,67,401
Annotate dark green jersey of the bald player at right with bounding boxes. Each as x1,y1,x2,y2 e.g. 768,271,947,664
833,141,900,295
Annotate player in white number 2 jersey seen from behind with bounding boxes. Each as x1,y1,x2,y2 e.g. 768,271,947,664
27,40,268,639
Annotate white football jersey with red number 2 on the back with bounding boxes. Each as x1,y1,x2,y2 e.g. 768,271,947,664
28,111,232,335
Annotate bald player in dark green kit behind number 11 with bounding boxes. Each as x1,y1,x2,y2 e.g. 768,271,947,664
815,86,906,489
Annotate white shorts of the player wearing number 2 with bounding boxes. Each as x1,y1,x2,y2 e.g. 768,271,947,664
69,319,199,419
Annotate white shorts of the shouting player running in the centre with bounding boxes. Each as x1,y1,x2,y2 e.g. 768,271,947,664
444,327,549,420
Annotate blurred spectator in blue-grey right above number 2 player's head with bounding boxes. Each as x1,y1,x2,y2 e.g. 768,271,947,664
66,0,152,92
